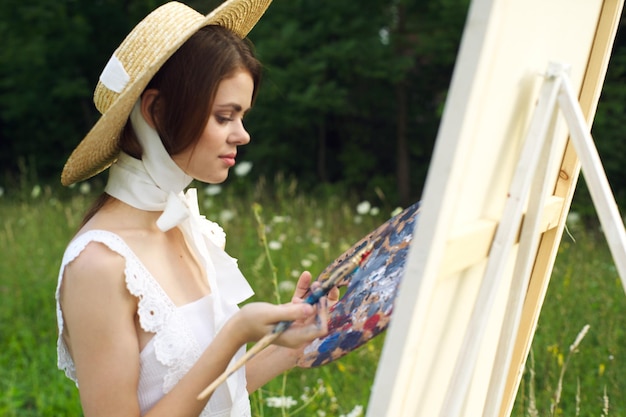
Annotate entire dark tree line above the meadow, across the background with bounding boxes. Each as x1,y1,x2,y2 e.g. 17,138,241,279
0,0,626,211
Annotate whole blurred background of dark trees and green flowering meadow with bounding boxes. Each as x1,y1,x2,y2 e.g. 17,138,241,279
0,0,626,417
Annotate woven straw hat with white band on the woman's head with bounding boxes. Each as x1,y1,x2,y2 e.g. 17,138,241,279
61,0,271,185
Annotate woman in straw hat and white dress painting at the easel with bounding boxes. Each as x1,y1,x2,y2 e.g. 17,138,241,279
57,0,337,417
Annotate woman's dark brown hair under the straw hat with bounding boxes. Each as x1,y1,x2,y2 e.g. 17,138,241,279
80,25,262,227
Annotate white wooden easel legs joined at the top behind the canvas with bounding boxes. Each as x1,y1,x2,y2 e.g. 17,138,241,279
440,64,626,417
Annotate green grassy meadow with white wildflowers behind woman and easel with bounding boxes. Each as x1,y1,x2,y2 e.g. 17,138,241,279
0,178,626,417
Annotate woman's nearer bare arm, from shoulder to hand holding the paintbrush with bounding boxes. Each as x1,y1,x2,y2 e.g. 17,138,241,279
61,243,325,417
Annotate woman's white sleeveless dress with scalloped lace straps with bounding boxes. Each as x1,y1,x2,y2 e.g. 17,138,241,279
56,230,250,417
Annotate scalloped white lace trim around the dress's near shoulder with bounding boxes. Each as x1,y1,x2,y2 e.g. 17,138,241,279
56,230,201,393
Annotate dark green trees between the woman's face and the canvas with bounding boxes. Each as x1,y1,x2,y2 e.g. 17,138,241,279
247,0,467,199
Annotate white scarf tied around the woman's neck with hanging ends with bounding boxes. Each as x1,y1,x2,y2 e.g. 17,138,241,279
105,101,254,398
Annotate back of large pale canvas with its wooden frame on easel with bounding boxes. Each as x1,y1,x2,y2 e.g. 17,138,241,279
368,0,623,417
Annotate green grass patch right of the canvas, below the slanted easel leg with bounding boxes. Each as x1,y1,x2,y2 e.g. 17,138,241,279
512,223,626,416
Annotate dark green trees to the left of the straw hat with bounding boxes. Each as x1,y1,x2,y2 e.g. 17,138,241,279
0,0,166,180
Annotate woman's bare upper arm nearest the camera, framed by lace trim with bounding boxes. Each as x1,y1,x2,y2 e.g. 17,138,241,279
60,243,147,417
